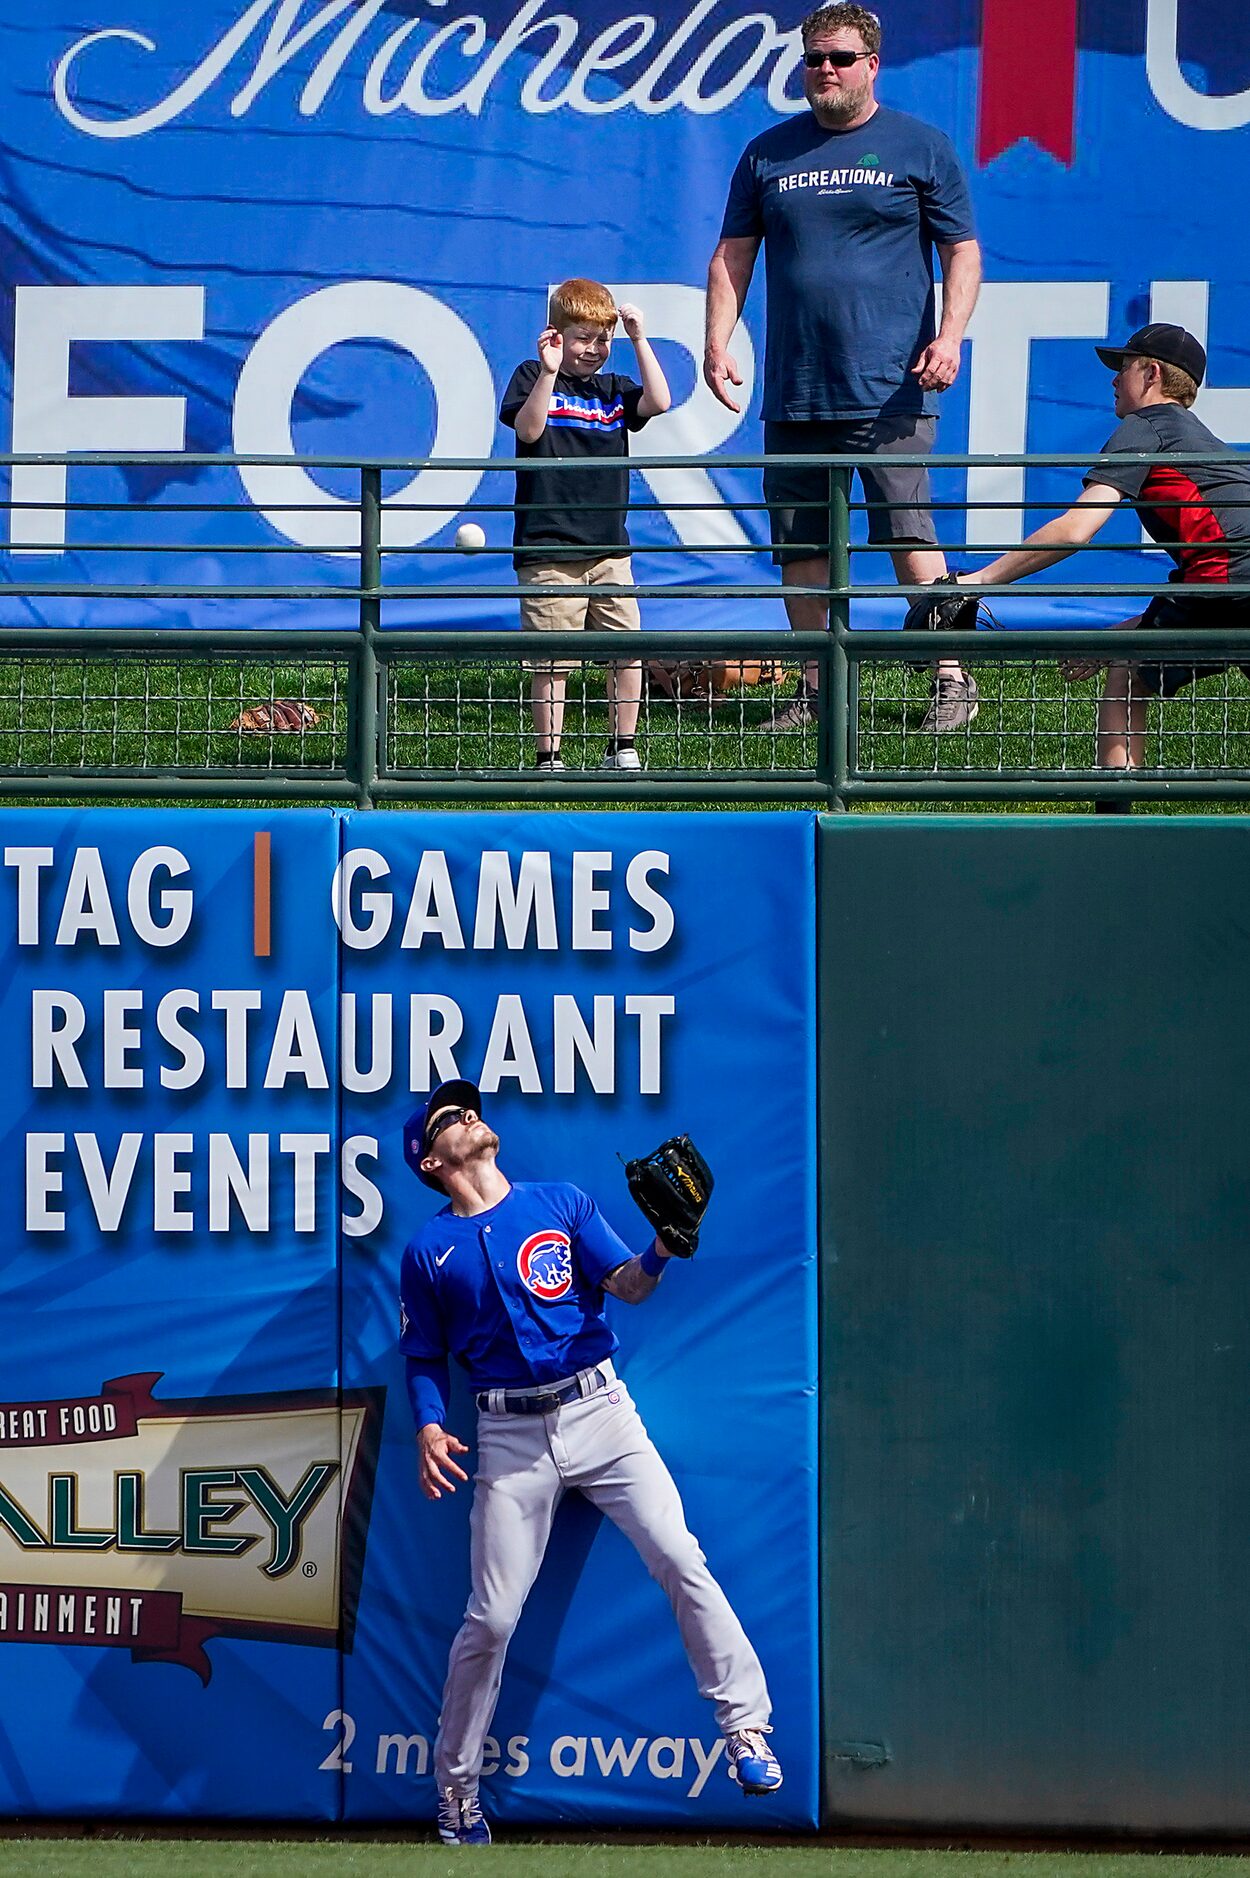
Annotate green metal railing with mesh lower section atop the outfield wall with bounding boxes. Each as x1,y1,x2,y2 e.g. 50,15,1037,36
0,454,1250,809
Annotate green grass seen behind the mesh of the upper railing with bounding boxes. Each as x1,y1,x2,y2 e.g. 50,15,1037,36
0,654,1250,811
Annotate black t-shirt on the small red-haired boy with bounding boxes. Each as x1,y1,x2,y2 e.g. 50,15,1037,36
499,359,646,567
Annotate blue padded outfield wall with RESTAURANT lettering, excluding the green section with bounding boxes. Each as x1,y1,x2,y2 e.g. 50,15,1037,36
0,809,820,1829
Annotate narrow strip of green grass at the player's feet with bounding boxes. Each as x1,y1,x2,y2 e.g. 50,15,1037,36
0,1837,1250,1878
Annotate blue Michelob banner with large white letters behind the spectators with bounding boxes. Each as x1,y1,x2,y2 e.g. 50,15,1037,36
0,0,1250,625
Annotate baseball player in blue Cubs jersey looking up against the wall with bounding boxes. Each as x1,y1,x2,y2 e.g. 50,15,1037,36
400,1080,781,1846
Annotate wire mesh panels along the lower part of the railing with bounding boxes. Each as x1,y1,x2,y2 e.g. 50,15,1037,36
0,633,1250,800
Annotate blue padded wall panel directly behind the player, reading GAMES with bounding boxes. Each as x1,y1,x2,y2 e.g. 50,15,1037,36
335,813,818,1831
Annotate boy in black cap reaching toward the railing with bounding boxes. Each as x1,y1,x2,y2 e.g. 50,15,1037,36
959,325,1250,813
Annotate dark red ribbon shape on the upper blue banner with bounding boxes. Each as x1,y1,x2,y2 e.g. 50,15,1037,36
976,0,1077,163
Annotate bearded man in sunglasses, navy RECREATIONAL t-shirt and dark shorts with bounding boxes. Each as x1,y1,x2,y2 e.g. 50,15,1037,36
704,6,982,731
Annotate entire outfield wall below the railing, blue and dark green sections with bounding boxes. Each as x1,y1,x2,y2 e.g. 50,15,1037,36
0,809,1250,1835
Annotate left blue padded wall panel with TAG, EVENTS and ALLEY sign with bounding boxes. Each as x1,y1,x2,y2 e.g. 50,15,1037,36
0,809,345,1820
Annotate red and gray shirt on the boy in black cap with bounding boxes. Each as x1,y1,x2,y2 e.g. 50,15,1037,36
1085,404,1250,582
